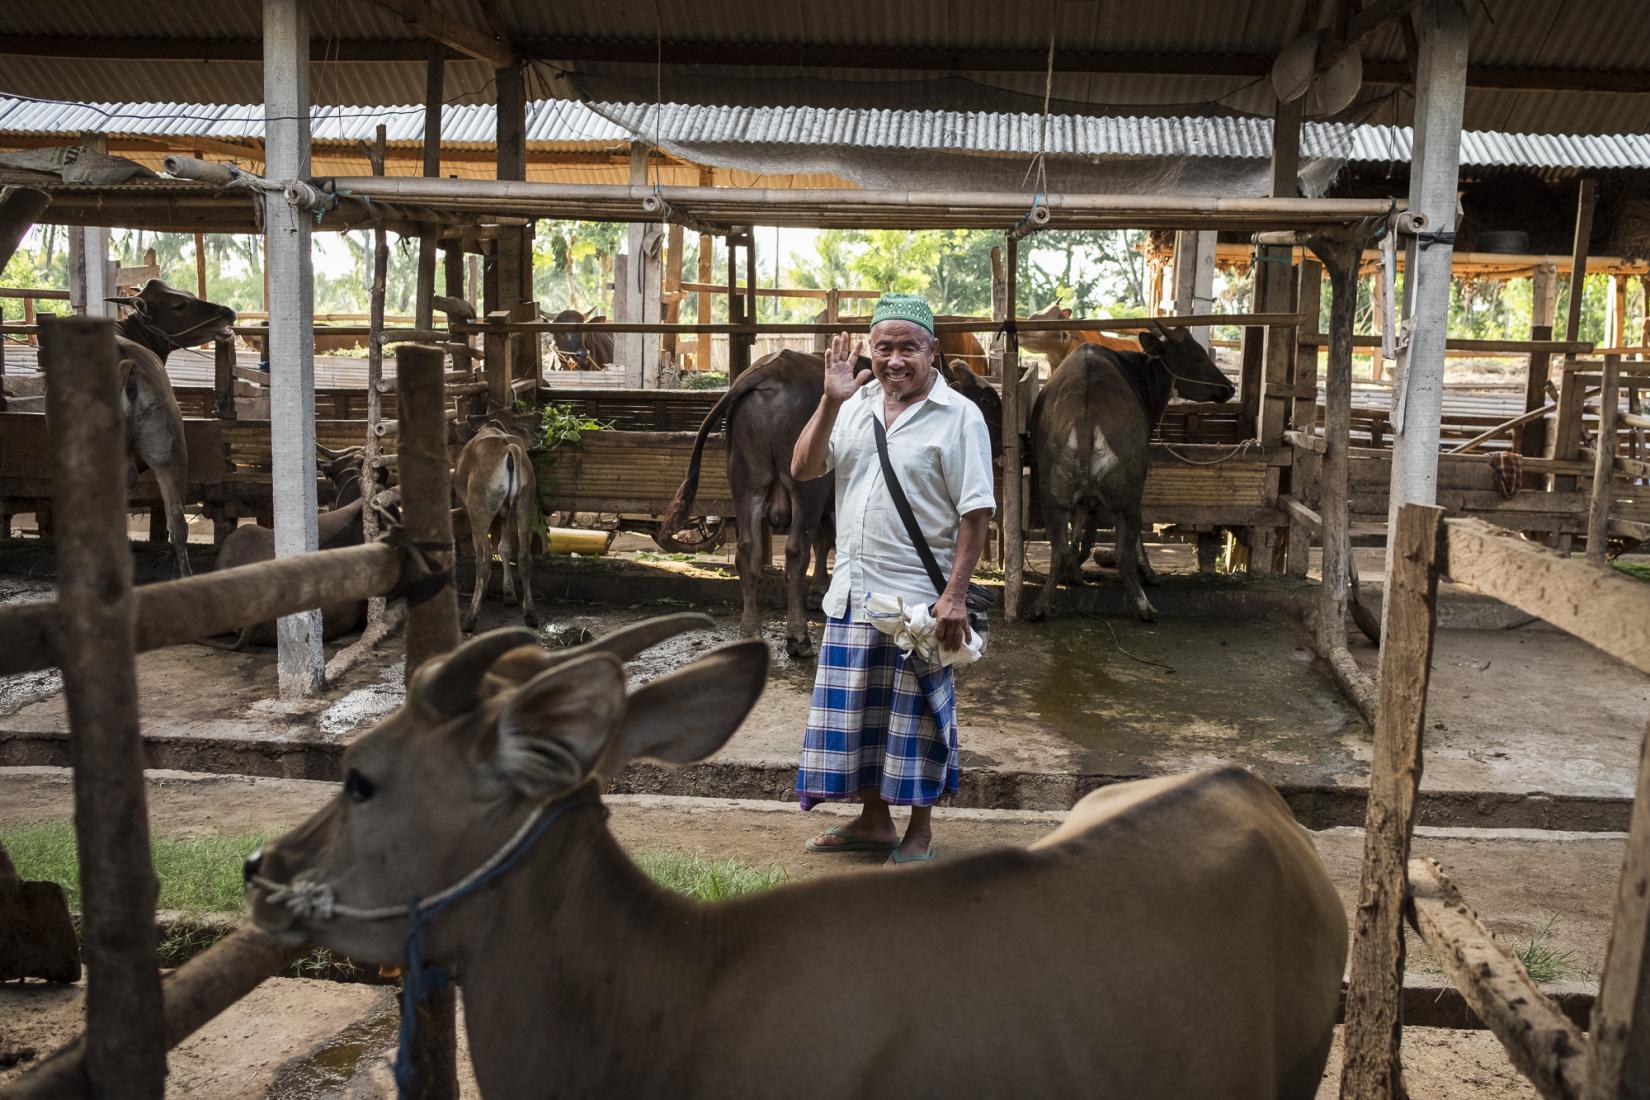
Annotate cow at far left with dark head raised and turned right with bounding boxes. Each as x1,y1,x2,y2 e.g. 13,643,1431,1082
109,279,234,577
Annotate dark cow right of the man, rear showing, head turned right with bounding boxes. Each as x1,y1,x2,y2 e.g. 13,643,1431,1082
1030,325,1236,622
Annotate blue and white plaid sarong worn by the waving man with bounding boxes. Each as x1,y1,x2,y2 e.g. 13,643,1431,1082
797,618,960,810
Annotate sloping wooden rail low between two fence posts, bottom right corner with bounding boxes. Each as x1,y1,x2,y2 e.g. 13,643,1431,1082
1409,859,1587,1100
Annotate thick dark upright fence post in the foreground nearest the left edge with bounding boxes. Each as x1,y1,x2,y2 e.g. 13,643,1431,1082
41,318,167,1098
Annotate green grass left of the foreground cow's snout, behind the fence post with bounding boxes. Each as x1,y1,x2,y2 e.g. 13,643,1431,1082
0,821,267,912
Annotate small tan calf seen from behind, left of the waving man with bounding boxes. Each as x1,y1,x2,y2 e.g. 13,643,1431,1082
452,421,538,630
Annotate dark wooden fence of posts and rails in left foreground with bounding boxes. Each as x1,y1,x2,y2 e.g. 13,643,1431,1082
0,339,459,1100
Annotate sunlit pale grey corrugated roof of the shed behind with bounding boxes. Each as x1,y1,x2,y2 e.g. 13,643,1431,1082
0,97,1650,170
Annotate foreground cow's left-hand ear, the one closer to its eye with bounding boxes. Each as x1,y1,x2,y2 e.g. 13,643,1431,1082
490,653,625,800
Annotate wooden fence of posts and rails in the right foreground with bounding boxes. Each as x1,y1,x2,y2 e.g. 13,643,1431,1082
1341,505,1650,1100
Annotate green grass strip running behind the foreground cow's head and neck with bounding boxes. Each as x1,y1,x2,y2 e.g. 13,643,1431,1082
0,821,787,916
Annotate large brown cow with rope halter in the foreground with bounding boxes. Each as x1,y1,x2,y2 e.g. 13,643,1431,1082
246,615,1346,1100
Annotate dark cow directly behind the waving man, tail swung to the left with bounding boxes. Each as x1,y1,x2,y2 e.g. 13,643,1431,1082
662,350,1003,656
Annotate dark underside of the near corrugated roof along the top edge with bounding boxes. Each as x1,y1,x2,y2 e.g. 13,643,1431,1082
0,0,1650,132
